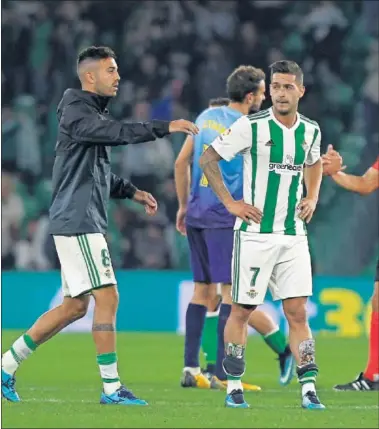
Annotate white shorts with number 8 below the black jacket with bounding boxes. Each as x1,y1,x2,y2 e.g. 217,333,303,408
54,233,116,298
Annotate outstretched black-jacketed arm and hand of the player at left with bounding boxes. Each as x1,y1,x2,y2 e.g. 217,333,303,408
60,102,198,146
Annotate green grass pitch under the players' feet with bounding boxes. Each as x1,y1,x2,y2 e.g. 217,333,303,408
2,331,379,428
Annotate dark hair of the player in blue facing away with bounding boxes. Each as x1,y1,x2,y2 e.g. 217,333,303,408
226,66,266,103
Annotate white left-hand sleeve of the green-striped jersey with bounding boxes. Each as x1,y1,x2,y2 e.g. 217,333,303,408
211,116,252,161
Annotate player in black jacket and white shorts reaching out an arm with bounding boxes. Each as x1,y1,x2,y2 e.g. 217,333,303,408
1,47,198,405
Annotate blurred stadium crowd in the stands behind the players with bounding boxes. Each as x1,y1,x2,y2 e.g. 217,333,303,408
1,0,379,275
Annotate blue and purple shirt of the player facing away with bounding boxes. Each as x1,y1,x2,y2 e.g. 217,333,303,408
186,106,243,228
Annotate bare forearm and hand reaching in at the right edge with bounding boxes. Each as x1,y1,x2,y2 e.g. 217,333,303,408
332,167,379,195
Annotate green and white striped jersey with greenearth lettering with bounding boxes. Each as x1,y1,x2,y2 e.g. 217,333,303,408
212,108,321,235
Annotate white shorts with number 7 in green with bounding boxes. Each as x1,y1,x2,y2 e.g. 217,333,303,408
232,231,312,305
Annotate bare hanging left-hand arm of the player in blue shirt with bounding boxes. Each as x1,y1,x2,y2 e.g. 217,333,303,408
174,136,194,235
